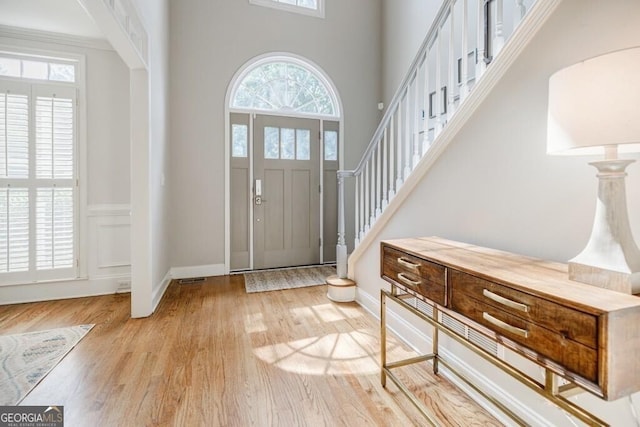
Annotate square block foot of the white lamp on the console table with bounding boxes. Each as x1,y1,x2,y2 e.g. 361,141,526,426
569,262,640,294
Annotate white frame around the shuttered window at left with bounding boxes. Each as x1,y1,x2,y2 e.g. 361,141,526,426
0,44,88,287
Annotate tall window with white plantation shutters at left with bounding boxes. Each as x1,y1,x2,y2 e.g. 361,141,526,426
0,53,78,283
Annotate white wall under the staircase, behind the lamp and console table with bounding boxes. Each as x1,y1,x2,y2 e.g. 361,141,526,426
353,0,640,426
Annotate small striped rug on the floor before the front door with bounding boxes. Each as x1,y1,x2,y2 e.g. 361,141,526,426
244,265,336,294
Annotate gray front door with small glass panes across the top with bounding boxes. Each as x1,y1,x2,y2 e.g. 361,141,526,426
251,115,320,269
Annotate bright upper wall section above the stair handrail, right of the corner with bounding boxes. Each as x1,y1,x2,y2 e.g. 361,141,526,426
381,0,442,107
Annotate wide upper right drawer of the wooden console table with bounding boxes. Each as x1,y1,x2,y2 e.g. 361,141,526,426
449,270,598,349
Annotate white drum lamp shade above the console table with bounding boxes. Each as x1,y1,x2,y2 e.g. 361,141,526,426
547,47,640,154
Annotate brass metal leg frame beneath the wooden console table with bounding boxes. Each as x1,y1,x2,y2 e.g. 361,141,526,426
380,284,609,426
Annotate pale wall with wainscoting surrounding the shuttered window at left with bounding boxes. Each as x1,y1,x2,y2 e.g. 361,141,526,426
0,27,131,304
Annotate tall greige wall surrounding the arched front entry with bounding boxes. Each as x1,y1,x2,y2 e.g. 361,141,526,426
170,0,381,268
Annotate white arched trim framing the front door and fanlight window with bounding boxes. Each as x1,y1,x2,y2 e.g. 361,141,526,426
224,52,344,274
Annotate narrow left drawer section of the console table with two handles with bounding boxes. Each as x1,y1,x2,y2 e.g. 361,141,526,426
382,246,447,305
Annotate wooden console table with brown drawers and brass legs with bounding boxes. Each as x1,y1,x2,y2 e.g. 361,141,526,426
380,237,640,426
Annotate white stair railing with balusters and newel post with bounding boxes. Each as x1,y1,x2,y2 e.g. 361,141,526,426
336,0,535,278
